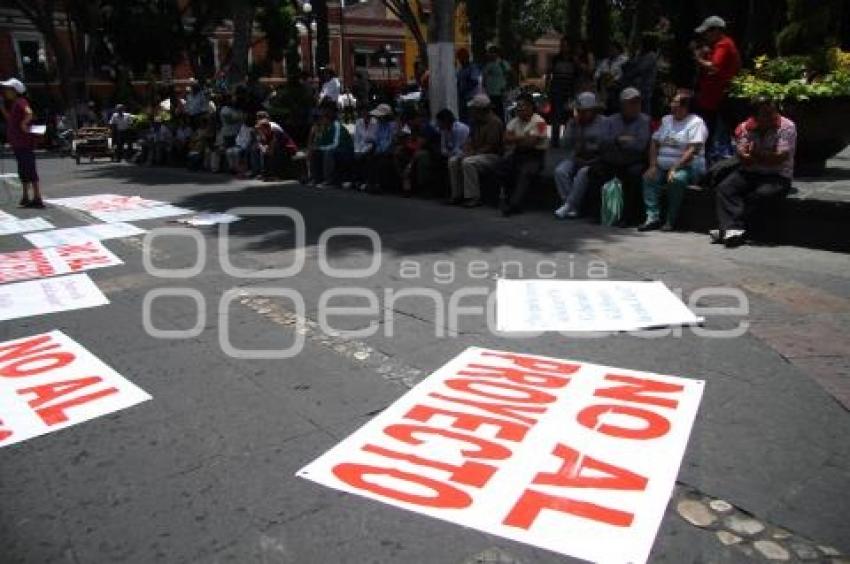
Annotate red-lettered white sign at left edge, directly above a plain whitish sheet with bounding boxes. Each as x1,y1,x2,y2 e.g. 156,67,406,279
0,241,124,283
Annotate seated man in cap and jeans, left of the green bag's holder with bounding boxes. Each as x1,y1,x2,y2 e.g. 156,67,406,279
555,92,606,219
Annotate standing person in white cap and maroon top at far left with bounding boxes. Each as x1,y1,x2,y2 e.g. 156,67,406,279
0,78,44,208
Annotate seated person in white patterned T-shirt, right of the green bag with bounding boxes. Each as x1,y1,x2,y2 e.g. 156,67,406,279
638,91,708,231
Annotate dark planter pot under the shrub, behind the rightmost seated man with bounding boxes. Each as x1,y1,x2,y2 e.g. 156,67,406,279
724,97,850,177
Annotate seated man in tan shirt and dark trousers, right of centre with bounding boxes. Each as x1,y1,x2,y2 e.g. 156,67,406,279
501,94,549,217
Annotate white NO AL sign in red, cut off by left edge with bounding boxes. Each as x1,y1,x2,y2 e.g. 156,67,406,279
0,331,151,447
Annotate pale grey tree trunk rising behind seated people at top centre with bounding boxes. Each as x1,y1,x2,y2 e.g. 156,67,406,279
428,0,458,116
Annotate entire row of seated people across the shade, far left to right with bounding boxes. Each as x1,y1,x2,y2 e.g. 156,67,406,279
110,77,796,246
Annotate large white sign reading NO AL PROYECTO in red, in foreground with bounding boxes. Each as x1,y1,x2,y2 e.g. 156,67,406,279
297,348,704,563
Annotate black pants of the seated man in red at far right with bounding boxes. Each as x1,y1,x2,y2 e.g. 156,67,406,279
715,170,791,229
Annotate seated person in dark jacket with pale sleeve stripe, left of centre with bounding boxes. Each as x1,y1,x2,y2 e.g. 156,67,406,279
310,100,354,188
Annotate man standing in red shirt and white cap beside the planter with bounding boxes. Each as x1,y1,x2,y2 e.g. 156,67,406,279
694,16,741,160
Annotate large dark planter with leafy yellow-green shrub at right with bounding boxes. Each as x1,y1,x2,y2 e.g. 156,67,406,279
726,48,850,176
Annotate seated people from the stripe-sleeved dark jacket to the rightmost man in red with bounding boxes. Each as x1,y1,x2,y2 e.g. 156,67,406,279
294,87,796,246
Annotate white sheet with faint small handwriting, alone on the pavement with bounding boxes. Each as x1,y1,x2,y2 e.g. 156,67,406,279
496,280,703,332
